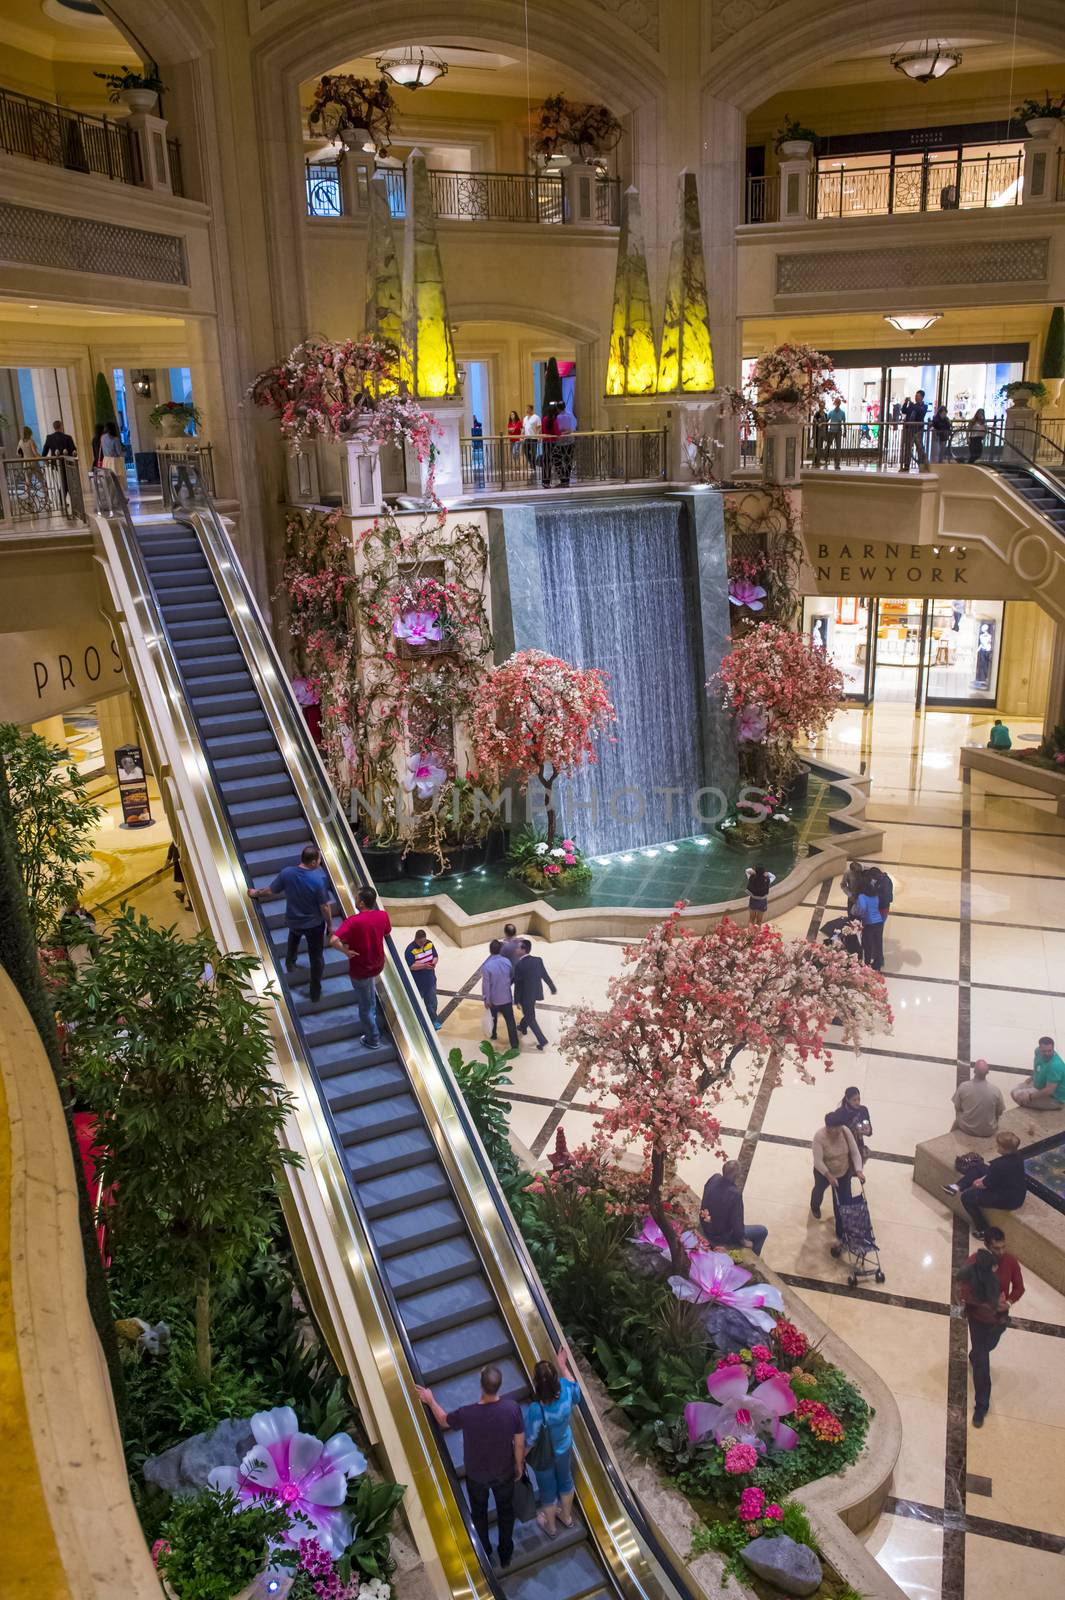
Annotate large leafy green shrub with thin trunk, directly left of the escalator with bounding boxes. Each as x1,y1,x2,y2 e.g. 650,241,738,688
62,909,299,1382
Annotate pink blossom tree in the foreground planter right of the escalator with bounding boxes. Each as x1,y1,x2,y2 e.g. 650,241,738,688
561,909,892,1274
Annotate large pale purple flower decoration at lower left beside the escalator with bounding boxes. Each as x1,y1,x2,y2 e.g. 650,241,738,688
208,1405,366,1557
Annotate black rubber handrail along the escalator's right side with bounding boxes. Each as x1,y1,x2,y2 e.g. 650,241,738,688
159,467,697,1600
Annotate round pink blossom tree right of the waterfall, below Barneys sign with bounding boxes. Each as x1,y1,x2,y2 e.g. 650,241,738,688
707,622,844,787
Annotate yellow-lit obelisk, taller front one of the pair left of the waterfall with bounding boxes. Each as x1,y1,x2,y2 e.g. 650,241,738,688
400,150,457,400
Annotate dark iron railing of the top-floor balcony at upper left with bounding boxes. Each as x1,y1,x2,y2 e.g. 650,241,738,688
0,88,182,195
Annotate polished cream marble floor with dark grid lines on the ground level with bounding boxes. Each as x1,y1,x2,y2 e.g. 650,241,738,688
433,704,1065,1600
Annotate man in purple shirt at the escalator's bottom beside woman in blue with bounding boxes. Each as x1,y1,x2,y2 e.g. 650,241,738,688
417,1369,525,1571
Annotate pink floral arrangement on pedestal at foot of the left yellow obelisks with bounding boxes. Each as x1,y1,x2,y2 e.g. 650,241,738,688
248,336,440,498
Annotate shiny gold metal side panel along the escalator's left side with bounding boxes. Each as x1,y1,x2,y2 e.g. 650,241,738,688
87,515,499,1600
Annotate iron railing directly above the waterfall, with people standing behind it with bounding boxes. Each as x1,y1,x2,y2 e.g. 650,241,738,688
462,427,668,491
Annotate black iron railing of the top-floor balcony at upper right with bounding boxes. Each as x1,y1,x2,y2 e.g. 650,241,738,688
745,154,1023,222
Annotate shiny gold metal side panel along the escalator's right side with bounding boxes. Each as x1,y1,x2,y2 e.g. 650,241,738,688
171,507,691,1600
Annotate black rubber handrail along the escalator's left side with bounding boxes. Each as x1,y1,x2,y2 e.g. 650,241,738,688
91,470,505,1600
